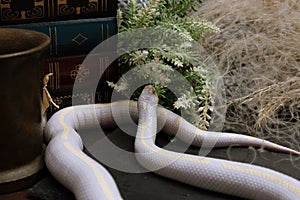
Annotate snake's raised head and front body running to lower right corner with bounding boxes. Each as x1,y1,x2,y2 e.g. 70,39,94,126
135,88,300,200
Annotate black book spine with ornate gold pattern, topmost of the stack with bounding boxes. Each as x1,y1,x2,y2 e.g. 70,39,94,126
0,0,118,25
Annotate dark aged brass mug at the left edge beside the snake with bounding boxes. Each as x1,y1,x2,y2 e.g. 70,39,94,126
0,28,50,193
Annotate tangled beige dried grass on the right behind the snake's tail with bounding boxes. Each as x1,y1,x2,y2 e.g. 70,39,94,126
193,0,300,150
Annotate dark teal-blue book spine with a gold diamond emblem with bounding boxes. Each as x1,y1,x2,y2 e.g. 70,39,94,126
6,17,117,57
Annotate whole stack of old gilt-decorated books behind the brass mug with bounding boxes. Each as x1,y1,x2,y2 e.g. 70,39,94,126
0,0,118,117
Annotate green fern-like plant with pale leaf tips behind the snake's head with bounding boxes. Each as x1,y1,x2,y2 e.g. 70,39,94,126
108,0,219,129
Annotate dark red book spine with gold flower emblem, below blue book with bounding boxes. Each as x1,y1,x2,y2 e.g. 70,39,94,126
44,52,117,91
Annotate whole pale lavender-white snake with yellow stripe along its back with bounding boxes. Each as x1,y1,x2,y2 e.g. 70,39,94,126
44,86,300,200
